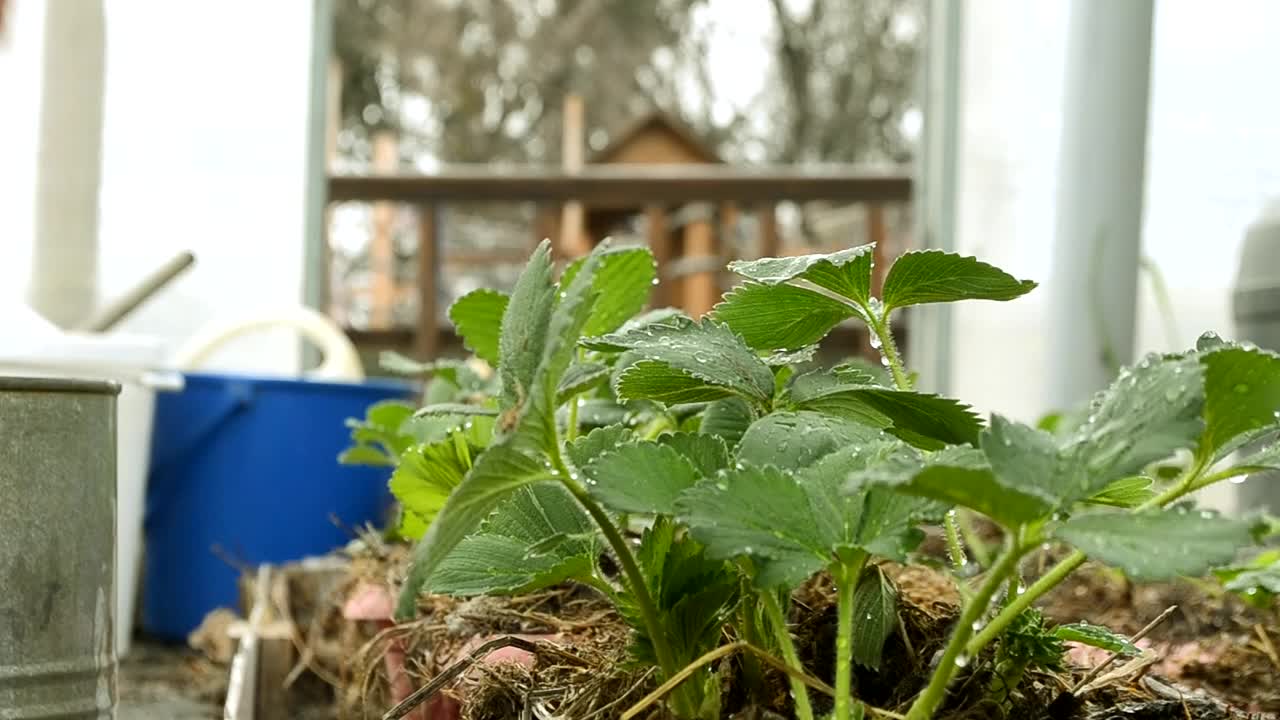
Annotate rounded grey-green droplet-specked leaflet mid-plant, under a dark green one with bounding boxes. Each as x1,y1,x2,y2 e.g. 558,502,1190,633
737,410,886,470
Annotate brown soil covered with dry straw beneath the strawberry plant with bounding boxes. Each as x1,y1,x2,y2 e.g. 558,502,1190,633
154,538,1280,720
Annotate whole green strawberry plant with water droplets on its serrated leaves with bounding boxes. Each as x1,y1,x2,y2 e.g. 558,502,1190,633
366,243,1280,720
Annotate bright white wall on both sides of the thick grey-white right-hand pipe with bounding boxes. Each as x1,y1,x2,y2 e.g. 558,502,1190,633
951,0,1280,420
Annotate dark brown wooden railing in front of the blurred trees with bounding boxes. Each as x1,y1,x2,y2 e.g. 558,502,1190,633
326,165,911,357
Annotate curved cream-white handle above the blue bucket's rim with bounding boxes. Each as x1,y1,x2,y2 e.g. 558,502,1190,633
174,306,365,382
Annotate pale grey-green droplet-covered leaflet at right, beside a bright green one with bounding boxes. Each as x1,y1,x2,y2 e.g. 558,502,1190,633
1064,355,1204,489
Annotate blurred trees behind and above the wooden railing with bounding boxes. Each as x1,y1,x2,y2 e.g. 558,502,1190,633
335,0,923,164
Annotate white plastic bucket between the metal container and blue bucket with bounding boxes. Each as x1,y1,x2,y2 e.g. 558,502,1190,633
0,326,182,656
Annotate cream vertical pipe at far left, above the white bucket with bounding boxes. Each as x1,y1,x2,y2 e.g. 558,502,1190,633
27,0,106,327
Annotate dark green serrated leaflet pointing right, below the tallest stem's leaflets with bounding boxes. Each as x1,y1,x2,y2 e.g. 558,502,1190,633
791,380,982,448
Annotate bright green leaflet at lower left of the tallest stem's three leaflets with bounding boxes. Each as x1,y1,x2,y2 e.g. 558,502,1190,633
712,282,854,350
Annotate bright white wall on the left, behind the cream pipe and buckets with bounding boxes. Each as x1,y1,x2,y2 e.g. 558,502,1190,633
0,0,312,374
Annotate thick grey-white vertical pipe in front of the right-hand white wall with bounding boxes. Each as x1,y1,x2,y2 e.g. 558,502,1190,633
1048,0,1152,407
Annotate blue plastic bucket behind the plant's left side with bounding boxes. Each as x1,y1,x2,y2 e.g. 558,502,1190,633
142,373,413,639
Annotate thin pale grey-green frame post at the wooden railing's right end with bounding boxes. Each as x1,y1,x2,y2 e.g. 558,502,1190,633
906,0,964,393
